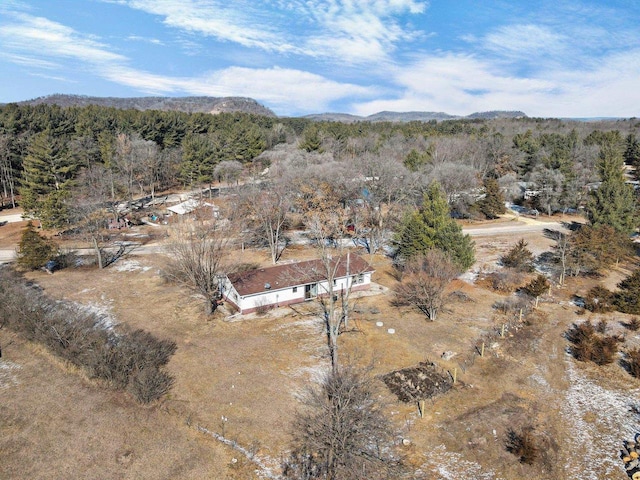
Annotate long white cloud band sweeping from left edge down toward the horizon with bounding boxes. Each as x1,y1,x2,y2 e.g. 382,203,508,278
0,10,375,113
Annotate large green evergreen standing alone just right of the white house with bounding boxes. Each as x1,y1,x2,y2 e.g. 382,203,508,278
395,182,475,270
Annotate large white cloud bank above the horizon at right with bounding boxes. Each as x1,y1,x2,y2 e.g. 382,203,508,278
354,49,640,117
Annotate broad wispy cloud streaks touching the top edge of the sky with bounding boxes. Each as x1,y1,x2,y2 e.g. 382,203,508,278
102,0,428,63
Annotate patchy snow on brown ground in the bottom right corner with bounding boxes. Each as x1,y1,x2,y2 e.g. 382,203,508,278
562,359,640,480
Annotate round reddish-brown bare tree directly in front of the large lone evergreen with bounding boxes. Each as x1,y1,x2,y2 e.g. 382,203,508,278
395,249,460,321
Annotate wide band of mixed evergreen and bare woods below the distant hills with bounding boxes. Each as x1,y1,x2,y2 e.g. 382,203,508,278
0,104,640,232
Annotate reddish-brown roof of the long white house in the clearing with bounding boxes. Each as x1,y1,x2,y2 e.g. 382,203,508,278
229,253,374,297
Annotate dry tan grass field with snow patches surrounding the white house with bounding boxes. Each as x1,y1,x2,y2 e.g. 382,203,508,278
0,216,640,479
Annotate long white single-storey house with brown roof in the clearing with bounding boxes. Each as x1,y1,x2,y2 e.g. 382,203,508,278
221,254,374,313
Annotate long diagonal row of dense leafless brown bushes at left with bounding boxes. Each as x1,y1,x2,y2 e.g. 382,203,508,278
0,267,177,403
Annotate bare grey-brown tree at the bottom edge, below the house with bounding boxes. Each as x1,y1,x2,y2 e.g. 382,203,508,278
284,366,403,480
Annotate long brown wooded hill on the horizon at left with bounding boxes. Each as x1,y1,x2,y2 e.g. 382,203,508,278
17,94,276,117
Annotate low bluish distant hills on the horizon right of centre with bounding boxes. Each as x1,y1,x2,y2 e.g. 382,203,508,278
303,110,527,123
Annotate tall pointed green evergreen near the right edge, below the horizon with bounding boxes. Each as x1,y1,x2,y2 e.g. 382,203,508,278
587,144,638,234
